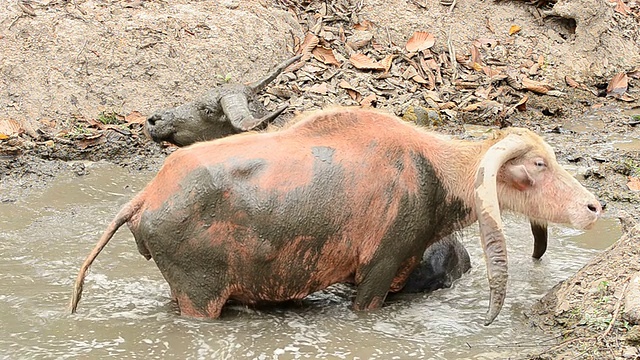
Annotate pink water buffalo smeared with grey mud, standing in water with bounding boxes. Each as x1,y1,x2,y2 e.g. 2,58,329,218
70,108,602,325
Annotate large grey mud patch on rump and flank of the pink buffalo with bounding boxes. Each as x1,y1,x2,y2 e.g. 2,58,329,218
134,153,345,311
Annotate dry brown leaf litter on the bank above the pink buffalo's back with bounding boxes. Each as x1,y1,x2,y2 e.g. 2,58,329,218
263,0,622,127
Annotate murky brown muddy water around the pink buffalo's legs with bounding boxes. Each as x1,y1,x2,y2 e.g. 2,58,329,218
0,164,619,359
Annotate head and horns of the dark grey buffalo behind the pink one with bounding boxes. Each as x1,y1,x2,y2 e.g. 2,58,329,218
145,55,301,146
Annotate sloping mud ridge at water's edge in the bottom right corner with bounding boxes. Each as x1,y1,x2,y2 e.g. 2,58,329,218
529,216,640,359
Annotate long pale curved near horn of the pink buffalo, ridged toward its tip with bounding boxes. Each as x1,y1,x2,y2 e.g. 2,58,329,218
475,134,530,325
